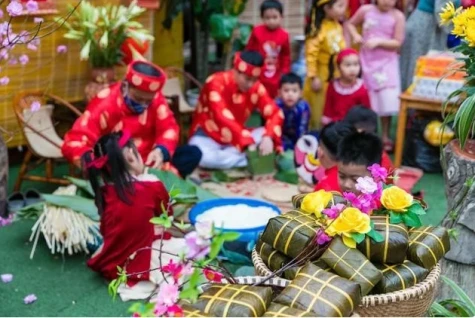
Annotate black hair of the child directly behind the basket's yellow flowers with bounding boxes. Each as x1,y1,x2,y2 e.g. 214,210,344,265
337,132,383,167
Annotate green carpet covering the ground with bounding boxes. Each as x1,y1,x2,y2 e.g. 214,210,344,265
0,166,447,316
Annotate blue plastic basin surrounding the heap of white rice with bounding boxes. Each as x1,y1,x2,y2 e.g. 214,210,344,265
189,198,280,242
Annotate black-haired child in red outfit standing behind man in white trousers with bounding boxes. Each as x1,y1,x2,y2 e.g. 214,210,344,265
246,0,290,98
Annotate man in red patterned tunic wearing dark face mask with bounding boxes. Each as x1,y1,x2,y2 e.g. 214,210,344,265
61,61,201,176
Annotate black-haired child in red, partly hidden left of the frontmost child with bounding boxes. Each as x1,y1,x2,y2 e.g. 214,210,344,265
315,122,354,191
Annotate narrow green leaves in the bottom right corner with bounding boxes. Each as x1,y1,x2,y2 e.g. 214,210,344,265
430,276,475,317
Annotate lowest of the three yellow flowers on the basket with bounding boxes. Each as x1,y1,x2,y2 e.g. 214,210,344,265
325,207,371,248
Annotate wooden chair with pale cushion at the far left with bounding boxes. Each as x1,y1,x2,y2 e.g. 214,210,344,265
13,92,81,191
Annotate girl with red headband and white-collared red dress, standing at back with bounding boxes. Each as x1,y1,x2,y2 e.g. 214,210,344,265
322,49,370,125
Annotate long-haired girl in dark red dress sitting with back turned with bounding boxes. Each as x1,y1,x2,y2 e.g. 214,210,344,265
83,132,184,300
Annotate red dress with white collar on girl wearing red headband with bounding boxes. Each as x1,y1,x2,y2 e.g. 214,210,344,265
323,79,371,122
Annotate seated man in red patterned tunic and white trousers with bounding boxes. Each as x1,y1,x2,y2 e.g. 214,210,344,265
189,51,284,169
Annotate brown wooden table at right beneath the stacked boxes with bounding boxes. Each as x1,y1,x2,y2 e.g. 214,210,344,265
394,93,454,168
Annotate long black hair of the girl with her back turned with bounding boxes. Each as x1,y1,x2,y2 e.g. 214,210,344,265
82,132,140,214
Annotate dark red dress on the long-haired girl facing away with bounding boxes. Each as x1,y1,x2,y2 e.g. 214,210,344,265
87,181,171,285
